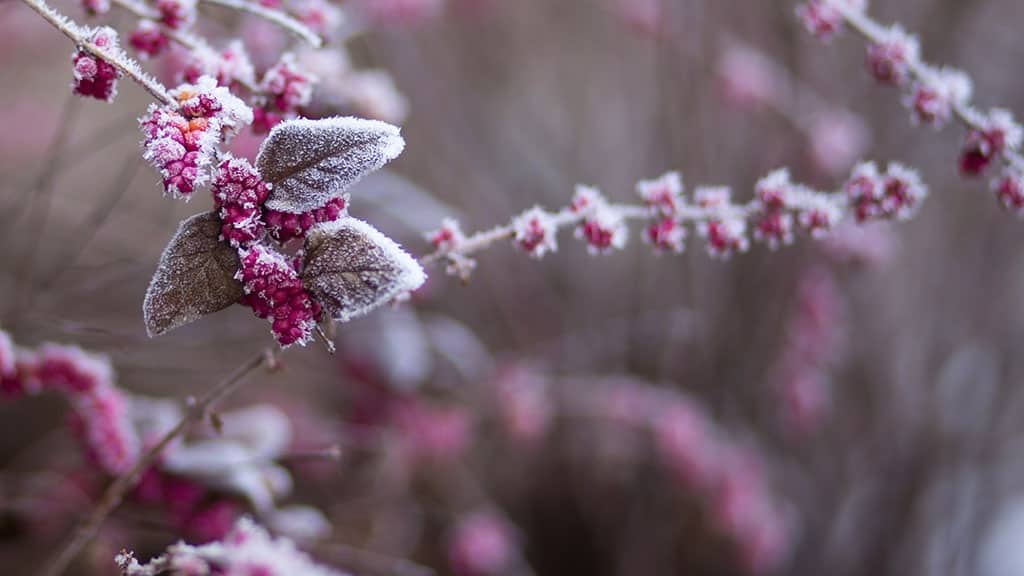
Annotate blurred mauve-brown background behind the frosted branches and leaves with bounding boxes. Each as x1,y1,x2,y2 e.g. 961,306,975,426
0,0,1024,576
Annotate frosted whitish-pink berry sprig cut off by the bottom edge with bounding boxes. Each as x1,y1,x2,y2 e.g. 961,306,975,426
115,519,342,576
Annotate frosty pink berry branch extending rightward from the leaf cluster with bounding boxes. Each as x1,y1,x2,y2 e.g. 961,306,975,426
421,163,928,280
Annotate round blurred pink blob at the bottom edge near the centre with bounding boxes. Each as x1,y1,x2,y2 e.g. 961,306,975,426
449,511,516,576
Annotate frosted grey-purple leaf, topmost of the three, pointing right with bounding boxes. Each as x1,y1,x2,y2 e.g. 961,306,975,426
256,117,406,213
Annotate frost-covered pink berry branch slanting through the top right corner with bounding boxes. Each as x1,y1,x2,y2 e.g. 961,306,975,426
797,0,1024,213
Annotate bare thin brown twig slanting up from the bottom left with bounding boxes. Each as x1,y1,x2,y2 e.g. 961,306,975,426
39,344,276,576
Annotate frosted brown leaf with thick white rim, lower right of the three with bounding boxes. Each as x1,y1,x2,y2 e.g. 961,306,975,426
302,217,427,322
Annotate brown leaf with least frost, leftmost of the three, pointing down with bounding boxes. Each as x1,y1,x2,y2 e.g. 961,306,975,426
142,212,243,336
